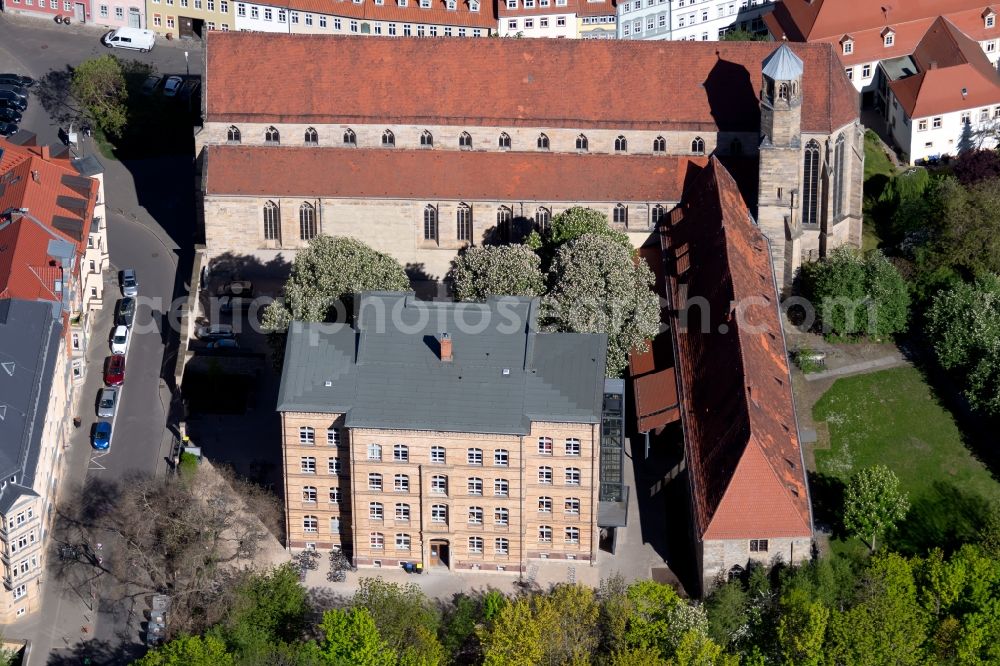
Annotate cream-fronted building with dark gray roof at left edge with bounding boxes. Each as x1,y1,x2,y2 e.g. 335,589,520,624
0,298,72,624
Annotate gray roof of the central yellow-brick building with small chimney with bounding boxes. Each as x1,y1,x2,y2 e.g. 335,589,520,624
278,292,607,435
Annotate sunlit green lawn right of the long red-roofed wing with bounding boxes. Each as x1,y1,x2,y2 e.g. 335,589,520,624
813,367,1000,551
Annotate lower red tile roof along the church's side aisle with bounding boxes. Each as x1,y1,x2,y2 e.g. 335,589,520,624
206,145,706,202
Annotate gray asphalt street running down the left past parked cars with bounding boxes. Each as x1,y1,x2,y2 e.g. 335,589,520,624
0,15,203,666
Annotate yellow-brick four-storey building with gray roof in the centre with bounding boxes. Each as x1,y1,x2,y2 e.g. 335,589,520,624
278,293,608,571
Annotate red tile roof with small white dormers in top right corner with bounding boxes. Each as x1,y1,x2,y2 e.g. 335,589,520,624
764,0,1000,66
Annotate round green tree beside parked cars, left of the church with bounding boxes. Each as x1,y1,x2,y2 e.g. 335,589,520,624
70,54,128,136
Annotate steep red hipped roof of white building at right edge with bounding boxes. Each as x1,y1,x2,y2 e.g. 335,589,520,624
889,18,1000,118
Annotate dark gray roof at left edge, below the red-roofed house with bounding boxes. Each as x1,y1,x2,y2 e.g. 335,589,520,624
0,299,62,513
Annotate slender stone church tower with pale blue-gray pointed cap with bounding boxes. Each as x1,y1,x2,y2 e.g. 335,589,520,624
757,44,803,294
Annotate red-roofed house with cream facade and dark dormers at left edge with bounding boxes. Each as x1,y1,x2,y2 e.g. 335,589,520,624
0,132,109,382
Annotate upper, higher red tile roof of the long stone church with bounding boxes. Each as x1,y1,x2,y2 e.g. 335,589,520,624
206,31,858,132
